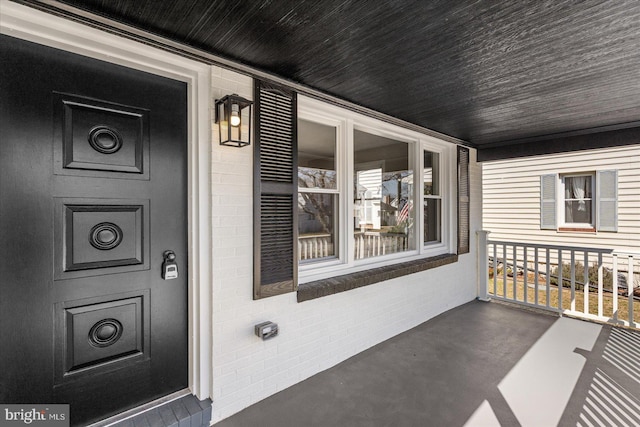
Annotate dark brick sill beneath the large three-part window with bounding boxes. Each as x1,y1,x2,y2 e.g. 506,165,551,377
298,254,458,302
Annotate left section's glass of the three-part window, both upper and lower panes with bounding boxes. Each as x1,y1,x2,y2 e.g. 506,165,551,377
298,119,338,262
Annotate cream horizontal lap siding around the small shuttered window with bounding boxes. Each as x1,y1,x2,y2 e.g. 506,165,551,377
482,145,640,252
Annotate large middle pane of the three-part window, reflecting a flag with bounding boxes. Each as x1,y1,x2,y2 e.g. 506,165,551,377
353,130,415,259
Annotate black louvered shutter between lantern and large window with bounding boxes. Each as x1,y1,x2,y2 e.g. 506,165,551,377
253,80,298,299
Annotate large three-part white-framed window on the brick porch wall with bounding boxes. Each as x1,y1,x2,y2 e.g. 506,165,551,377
297,96,456,283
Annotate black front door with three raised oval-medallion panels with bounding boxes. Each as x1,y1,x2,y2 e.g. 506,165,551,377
0,36,188,424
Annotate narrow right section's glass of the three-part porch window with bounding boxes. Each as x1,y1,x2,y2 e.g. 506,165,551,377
422,151,442,244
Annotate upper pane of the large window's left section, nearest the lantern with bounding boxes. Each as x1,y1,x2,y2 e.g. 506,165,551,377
298,120,337,189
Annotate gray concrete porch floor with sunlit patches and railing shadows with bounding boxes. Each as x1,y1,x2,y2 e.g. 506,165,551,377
213,301,640,427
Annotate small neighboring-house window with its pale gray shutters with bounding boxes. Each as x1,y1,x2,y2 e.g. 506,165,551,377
540,170,618,232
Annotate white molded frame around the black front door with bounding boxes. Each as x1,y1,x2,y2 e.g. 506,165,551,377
0,0,212,399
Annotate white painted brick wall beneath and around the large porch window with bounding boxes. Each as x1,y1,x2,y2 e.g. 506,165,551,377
211,67,482,422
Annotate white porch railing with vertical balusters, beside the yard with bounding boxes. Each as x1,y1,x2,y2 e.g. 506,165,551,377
478,231,640,329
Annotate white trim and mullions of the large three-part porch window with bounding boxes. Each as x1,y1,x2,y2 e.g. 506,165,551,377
297,95,457,283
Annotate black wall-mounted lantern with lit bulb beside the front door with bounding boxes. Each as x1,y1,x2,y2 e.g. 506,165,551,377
216,93,253,147
